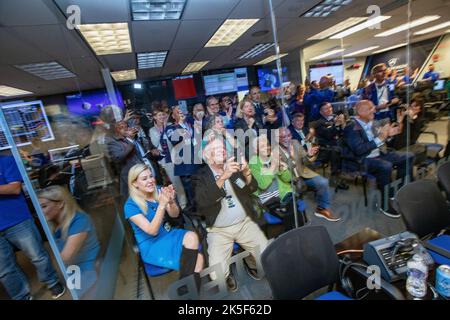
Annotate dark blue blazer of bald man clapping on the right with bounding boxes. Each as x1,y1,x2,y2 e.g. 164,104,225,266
342,120,377,171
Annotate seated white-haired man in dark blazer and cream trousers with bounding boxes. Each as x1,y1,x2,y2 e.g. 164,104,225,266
192,138,267,291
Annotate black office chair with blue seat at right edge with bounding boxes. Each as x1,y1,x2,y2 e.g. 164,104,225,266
396,180,450,264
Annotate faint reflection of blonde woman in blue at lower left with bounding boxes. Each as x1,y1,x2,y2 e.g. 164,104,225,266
38,186,100,297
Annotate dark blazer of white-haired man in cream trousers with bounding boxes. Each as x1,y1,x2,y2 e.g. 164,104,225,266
192,165,258,227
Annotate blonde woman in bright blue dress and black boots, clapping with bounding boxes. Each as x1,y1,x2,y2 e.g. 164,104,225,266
124,164,203,289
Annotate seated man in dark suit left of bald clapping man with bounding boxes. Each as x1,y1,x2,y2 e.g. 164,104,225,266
314,102,348,190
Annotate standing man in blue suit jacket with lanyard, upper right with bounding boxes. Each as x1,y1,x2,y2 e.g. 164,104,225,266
363,63,400,120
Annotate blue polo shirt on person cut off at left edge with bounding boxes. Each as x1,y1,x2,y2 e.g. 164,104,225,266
0,156,31,231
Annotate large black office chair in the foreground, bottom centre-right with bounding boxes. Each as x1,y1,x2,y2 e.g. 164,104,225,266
261,226,403,300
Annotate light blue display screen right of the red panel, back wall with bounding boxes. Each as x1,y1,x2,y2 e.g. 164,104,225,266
203,68,248,96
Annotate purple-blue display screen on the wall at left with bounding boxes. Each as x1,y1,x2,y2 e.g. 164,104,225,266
66,90,124,116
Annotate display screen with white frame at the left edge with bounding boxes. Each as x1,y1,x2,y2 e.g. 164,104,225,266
0,101,55,150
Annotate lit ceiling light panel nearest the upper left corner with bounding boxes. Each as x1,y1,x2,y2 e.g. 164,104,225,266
80,22,132,56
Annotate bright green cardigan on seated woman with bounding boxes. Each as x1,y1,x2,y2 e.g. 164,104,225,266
249,156,292,199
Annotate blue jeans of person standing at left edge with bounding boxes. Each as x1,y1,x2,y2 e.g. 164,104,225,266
0,219,59,300
